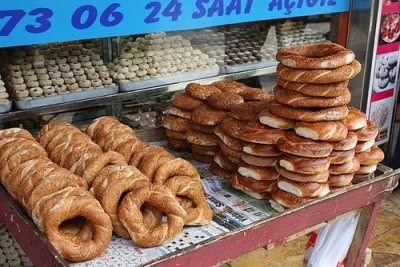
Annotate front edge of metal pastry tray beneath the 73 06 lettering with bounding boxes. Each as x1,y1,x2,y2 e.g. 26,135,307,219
14,86,118,110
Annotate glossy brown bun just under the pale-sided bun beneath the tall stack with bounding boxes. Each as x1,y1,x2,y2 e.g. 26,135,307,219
278,132,333,158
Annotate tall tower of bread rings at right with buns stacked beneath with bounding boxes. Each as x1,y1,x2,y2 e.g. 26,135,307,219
259,43,383,207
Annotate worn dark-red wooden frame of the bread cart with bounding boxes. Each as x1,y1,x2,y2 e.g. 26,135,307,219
0,165,400,267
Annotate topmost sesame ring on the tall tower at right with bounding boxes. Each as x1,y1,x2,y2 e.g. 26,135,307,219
276,43,355,69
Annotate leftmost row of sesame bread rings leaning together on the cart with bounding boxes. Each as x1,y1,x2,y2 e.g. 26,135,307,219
0,128,112,261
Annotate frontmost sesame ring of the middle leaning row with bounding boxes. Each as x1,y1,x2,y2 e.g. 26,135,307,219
118,184,187,247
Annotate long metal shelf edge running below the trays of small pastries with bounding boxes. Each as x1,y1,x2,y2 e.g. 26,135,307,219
0,66,276,123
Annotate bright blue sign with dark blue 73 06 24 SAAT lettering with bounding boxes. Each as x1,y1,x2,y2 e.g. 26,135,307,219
0,0,350,47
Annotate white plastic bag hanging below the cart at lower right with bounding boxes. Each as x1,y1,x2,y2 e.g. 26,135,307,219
303,211,360,267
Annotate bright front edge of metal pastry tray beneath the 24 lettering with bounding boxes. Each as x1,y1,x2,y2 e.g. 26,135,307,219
119,67,220,92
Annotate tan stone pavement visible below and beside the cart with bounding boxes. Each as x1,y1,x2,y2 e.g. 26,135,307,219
221,188,400,267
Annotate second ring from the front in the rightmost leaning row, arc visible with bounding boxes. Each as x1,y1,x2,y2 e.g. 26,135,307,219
153,158,200,184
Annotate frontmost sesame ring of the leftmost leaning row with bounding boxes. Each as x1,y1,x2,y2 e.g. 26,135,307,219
33,187,112,262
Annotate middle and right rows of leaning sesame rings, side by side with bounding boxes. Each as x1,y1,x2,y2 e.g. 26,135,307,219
38,117,213,247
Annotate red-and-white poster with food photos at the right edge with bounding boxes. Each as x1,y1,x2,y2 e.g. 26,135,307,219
367,0,400,145
